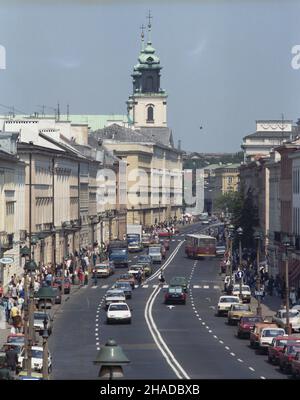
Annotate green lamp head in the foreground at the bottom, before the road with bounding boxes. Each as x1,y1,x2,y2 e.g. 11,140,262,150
94,339,130,380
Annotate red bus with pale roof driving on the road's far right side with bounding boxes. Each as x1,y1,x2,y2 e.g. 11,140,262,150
185,235,217,258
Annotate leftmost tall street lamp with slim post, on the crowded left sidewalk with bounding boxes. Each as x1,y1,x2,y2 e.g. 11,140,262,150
24,258,38,376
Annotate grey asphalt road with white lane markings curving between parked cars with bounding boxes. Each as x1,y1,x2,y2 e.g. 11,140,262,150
49,225,286,380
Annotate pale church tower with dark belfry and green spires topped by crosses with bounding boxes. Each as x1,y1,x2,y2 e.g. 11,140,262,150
127,12,168,128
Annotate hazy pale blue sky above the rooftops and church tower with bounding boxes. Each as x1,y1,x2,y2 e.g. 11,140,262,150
0,0,300,152
